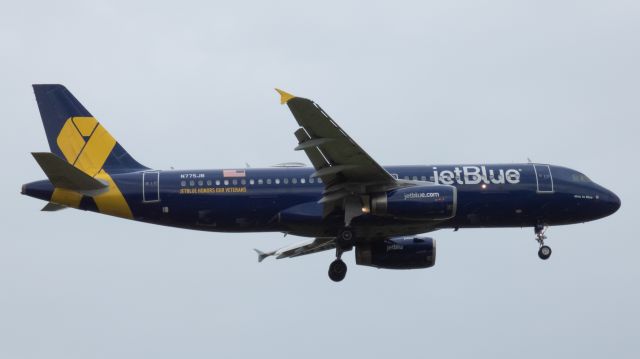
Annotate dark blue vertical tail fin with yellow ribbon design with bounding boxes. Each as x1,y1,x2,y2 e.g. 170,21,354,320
33,85,147,177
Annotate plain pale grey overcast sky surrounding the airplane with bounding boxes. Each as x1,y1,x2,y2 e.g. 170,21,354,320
0,0,640,358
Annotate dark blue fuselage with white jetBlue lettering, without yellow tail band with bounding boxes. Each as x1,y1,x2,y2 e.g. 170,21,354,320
23,163,620,237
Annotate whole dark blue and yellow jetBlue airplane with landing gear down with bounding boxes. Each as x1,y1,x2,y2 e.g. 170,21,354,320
22,84,620,282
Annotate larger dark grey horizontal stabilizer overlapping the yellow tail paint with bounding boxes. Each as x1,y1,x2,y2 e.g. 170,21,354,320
32,152,109,194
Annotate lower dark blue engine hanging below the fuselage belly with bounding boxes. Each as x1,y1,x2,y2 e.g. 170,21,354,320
356,237,436,269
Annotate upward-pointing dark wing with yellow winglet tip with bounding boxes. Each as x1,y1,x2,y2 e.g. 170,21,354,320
276,89,396,188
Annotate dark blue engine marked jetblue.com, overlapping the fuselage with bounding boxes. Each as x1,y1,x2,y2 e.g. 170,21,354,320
371,184,457,220
